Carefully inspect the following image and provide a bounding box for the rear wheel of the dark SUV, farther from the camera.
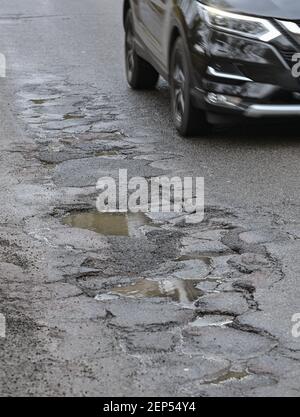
[125,10,159,90]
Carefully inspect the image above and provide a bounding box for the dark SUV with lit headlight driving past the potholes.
[124,0,300,135]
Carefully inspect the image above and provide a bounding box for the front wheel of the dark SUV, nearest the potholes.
[170,37,209,136]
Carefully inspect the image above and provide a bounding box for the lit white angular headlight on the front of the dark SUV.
[199,4,281,42]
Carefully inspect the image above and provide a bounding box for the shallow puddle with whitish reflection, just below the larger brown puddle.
[106,279,203,304]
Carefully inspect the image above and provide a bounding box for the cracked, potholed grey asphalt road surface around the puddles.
[0,0,300,397]
